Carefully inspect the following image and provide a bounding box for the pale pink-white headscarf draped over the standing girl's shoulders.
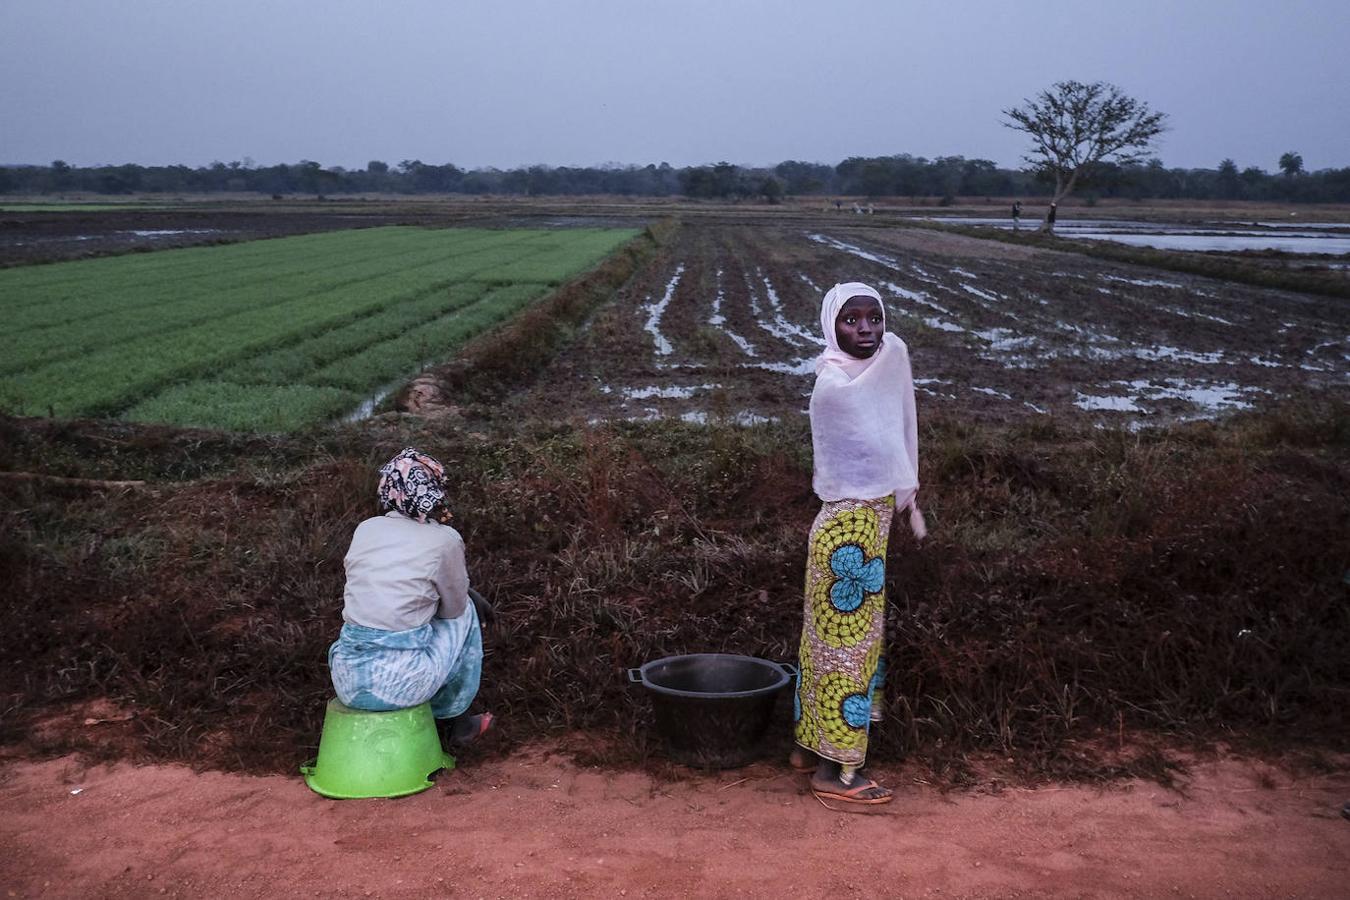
[810,282,925,537]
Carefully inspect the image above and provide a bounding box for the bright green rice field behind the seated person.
[0,227,637,430]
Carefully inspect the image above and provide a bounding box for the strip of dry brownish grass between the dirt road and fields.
[0,405,1350,781]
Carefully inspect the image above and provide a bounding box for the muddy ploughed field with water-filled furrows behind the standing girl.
[507,223,1350,428]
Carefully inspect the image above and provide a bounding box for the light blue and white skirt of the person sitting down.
[328,603,483,719]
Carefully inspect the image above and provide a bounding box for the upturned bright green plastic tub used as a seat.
[300,699,455,800]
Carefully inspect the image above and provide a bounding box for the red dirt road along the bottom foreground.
[0,752,1350,897]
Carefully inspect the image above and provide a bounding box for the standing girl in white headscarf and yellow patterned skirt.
[791,282,925,804]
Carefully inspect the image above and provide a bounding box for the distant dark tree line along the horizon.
[0,152,1350,202]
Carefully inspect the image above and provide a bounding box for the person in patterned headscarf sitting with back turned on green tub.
[328,448,493,743]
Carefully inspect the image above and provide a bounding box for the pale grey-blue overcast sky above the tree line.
[0,0,1350,170]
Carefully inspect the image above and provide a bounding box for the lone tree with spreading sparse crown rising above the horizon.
[1003,81,1166,231]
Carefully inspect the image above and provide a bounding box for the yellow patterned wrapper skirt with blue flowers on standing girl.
[792,497,895,766]
